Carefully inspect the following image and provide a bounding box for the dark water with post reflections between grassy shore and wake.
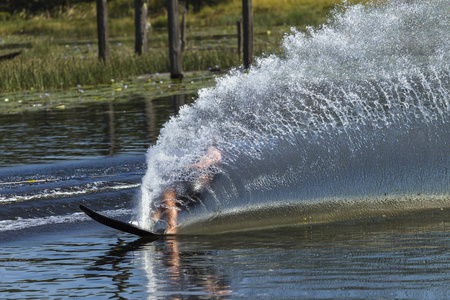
[0,95,193,167]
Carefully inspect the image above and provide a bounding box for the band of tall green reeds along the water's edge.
[0,49,244,92]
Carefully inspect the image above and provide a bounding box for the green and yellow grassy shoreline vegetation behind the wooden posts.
[0,0,362,113]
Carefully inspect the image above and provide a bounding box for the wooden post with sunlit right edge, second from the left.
[134,0,148,55]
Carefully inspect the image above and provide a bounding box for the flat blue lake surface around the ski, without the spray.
[0,98,450,299]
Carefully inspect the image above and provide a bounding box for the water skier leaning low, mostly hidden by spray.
[153,146,222,234]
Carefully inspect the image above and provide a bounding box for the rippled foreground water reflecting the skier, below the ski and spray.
[0,211,450,299]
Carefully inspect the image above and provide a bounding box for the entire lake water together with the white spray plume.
[0,0,450,299]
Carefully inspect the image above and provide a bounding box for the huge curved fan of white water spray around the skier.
[138,0,450,233]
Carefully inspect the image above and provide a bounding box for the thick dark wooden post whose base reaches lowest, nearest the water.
[167,0,183,79]
